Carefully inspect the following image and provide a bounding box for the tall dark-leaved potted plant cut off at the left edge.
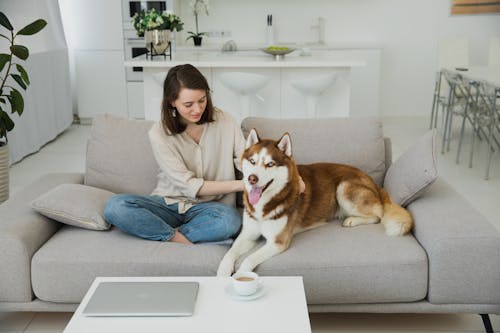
[0,12,47,203]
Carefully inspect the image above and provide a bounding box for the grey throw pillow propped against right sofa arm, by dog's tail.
[384,130,437,207]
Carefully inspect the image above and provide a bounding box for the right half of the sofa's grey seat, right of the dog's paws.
[252,221,428,304]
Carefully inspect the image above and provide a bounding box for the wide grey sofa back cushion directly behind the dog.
[242,117,386,185]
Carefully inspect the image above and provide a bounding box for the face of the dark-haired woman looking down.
[172,88,207,125]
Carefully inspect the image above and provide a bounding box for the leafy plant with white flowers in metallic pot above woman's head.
[132,8,184,55]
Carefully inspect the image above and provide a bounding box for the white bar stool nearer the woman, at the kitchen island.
[219,72,271,119]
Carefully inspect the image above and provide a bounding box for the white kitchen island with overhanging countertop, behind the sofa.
[125,50,372,120]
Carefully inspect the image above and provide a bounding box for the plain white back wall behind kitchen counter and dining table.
[178,0,500,116]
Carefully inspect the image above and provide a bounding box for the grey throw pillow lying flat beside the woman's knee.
[31,184,114,230]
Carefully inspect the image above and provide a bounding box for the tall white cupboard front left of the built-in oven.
[57,0,127,121]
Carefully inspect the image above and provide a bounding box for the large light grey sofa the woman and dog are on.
[0,115,500,330]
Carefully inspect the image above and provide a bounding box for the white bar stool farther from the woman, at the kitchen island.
[291,72,338,118]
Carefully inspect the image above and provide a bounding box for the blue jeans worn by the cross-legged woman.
[104,194,242,243]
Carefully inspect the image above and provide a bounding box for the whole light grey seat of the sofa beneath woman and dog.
[32,221,428,304]
